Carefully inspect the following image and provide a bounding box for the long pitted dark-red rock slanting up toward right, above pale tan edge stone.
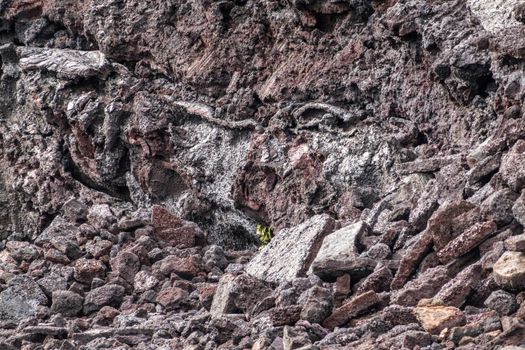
[437,221,497,264]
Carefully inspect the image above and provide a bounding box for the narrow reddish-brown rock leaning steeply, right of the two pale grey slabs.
[390,230,433,289]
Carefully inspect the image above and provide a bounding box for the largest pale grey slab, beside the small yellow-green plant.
[246,214,334,282]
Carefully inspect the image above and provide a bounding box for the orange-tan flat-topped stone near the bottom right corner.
[414,306,466,335]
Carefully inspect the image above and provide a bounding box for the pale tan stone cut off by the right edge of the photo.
[493,252,525,290]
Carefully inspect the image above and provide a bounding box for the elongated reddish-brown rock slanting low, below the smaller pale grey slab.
[323,291,380,328]
